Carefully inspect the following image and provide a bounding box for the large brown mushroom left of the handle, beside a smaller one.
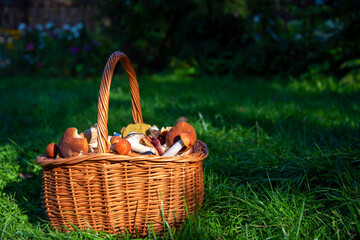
[58,127,89,158]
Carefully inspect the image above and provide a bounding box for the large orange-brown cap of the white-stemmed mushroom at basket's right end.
[166,122,196,152]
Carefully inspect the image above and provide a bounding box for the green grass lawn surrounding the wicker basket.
[0,72,360,239]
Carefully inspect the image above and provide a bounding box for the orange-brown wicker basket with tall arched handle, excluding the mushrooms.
[36,52,208,235]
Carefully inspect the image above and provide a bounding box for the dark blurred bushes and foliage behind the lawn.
[0,0,360,81]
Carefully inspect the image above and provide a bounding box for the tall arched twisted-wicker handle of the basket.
[97,52,143,153]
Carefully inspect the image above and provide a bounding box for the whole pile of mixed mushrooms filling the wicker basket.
[46,121,196,158]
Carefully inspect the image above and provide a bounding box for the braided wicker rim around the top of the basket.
[35,140,209,168]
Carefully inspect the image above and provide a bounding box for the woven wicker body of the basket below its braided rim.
[43,160,204,236]
